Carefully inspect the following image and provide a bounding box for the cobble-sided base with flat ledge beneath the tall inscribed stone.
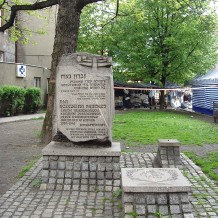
[41,141,121,191]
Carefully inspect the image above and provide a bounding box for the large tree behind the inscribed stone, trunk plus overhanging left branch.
[0,0,100,143]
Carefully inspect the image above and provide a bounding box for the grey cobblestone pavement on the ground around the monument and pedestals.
[0,153,218,218]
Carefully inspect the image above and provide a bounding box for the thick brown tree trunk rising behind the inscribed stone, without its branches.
[41,0,83,143]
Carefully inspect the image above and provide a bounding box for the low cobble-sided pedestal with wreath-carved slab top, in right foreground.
[121,168,193,218]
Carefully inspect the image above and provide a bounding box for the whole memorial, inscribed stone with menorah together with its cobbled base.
[42,53,121,190]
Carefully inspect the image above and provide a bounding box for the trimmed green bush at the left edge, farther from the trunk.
[0,86,25,116]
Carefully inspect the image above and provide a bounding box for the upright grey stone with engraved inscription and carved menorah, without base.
[53,53,114,146]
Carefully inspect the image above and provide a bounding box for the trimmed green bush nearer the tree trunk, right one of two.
[24,88,42,113]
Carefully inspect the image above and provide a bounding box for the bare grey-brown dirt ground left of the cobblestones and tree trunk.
[0,120,44,196]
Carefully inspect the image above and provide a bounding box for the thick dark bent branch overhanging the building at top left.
[0,0,58,31]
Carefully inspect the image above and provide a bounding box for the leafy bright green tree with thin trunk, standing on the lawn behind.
[79,0,217,106]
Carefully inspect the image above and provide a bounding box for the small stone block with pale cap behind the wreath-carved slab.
[154,139,181,168]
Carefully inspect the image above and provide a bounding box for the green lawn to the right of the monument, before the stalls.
[113,111,218,146]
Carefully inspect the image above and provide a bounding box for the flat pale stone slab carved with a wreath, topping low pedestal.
[121,168,191,192]
